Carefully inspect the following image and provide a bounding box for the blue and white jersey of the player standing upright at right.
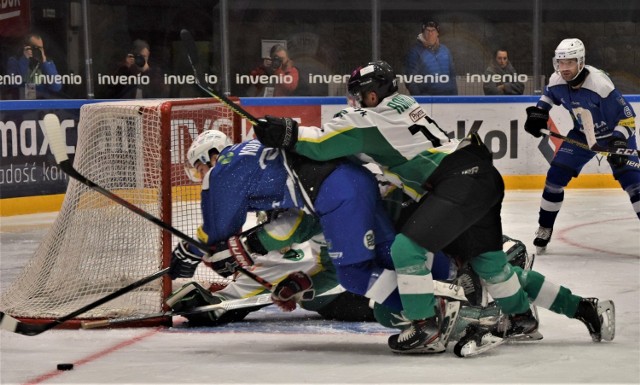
[537,66,635,146]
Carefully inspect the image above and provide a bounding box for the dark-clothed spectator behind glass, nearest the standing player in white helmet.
[483,48,524,95]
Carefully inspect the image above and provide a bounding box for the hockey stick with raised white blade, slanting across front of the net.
[44,114,273,290]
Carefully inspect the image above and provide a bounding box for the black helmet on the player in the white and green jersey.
[347,60,398,106]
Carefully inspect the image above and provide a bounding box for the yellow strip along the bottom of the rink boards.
[0,174,620,217]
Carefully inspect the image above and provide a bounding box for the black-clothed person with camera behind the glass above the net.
[109,39,169,99]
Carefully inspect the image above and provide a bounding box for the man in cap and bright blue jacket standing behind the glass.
[405,20,458,95]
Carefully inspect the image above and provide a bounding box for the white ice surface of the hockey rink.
[0,189,640,384]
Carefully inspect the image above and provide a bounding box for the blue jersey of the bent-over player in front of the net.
[198,140,303,245]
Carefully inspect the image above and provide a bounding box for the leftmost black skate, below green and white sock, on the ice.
[388,298,460,354]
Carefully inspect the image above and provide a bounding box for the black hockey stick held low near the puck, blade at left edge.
[0,267,169,336]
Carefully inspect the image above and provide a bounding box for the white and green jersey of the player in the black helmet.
[295,93,459,200]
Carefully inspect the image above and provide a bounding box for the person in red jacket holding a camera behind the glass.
[251,44,300,96]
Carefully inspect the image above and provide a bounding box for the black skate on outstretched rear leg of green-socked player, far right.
[575,298,616,342]
